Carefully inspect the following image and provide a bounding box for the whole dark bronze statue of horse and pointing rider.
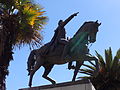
[27,12,101,87]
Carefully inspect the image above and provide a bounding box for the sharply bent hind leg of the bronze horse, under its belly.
[42,64,56,84]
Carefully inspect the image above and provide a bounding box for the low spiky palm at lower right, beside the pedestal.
[80,48,120,90]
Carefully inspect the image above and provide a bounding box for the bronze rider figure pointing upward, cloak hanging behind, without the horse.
[47,12,78,53]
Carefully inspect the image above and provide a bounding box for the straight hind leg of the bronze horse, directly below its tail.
[29,59,43,87]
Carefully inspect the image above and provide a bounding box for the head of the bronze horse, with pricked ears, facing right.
[85,20,101,43]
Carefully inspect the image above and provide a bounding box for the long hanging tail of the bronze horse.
[27,50,36,75]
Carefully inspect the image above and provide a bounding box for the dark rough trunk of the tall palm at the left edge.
[0,16,13,90]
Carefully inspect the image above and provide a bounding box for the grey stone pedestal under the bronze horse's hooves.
[19,80,95,90]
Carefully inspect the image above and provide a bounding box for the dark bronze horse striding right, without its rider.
[28,21,101,87]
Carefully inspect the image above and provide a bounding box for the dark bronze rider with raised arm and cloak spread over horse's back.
[41,12,78,56]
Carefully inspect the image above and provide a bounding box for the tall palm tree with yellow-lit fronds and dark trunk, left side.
[0,0,47,90]
